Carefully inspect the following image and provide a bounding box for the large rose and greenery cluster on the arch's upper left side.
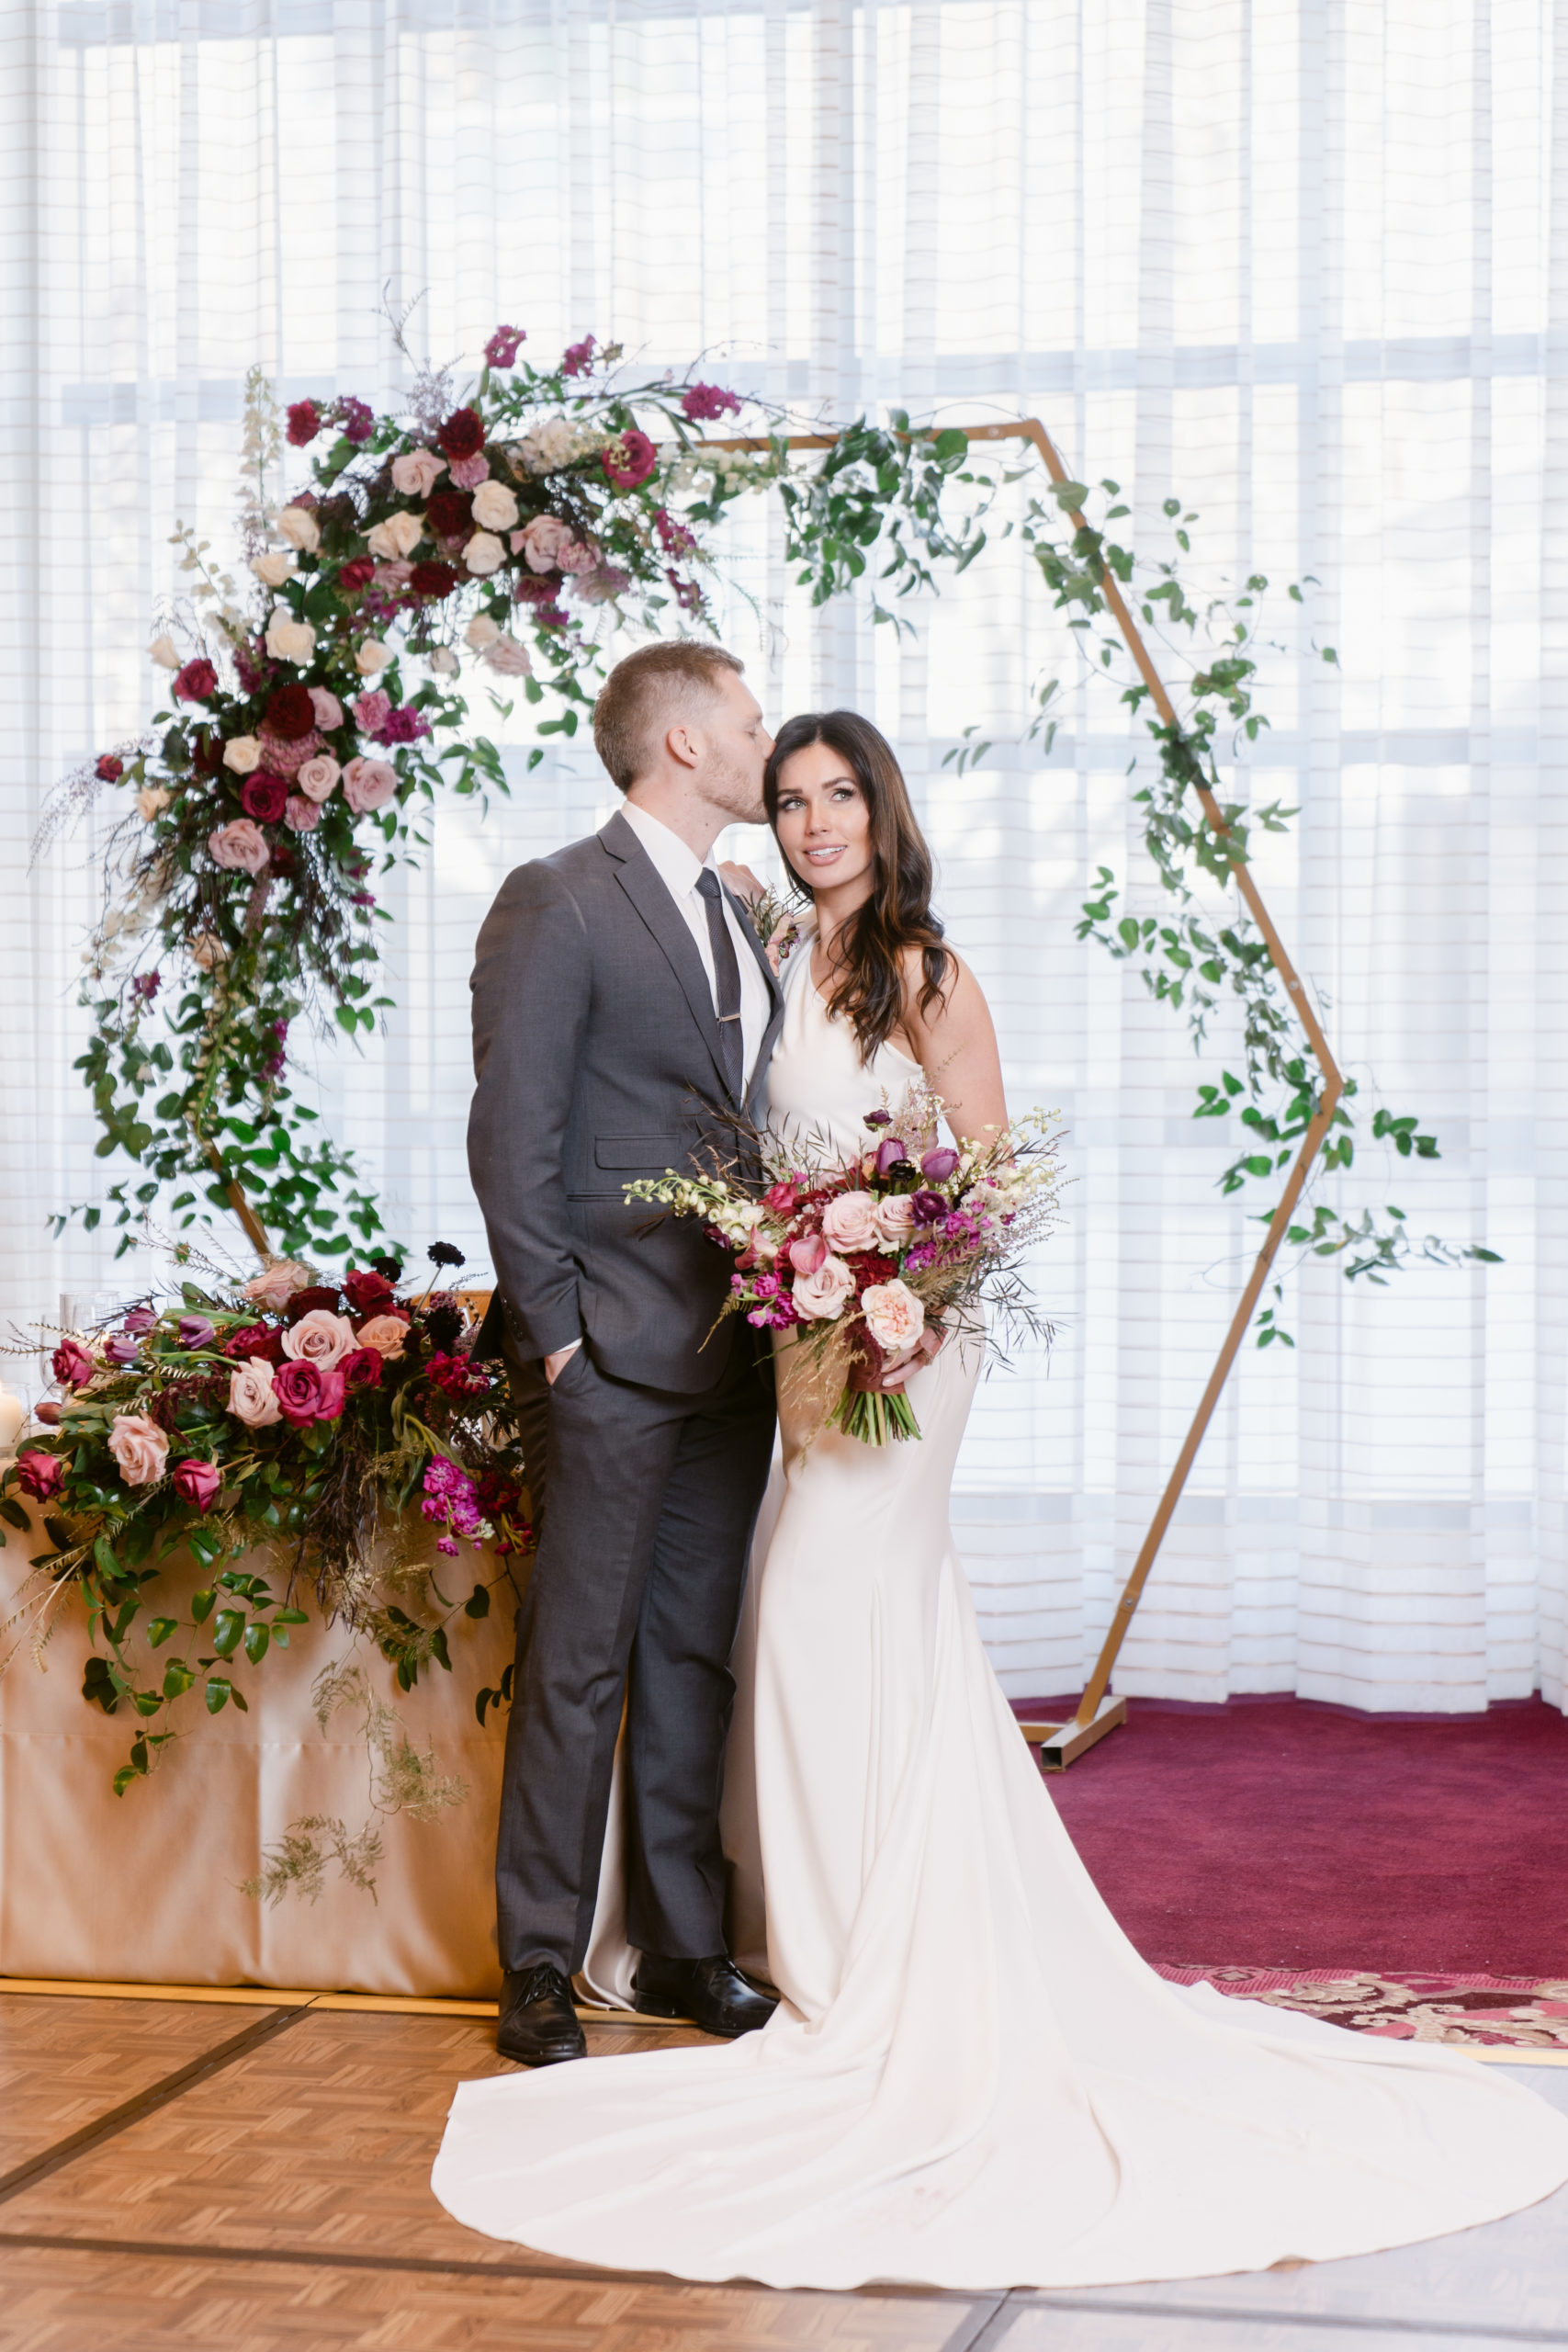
[40,327,983,1259]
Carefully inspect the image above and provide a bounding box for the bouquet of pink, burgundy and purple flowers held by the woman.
[626,1084,1060,1446]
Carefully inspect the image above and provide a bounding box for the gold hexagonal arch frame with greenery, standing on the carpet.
[724,416,1345,1771]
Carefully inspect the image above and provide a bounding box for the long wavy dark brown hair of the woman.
[761,710,952,1061]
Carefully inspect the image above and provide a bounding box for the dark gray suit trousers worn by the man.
[496,1322,773,1973]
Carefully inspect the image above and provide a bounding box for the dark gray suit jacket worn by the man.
[468,814,783,1395]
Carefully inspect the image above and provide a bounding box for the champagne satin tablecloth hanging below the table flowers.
[0,1529,513,1999]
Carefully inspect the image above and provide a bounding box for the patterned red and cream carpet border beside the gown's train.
[1156,1964,1568,2051]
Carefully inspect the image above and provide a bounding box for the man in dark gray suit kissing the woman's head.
[468,644,783,2065]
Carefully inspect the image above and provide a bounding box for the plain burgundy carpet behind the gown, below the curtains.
[1016,1698,1568,1978]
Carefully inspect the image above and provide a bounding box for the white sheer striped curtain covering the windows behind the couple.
[0,0,1568,1710]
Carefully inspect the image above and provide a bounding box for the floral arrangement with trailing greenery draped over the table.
[0,1242,534,1898]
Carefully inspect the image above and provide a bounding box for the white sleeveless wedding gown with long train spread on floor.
[433,945,1568,2289]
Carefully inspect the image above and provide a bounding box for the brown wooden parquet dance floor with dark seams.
[0,1992,1004,2352]
